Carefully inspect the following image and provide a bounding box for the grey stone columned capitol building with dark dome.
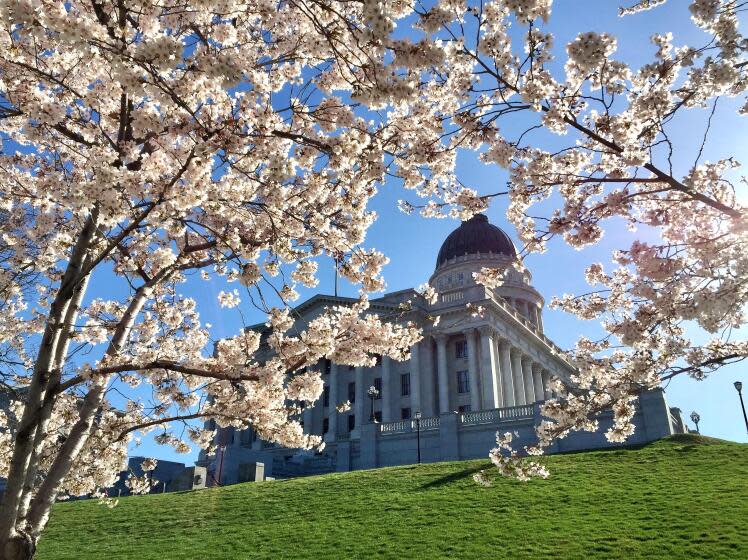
[198,214,685,484]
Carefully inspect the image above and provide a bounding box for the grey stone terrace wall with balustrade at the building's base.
[215,389,684,484]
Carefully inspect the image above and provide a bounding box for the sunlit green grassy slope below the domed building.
[39,436,748,560]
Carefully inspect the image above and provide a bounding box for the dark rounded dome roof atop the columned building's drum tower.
[436,214,517,270]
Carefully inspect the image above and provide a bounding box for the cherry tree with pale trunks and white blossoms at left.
[0,0,426,559]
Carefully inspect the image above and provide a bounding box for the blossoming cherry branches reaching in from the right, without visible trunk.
[398,0,748,479]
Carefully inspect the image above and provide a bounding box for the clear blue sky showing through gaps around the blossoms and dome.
[79,0,748,463]
